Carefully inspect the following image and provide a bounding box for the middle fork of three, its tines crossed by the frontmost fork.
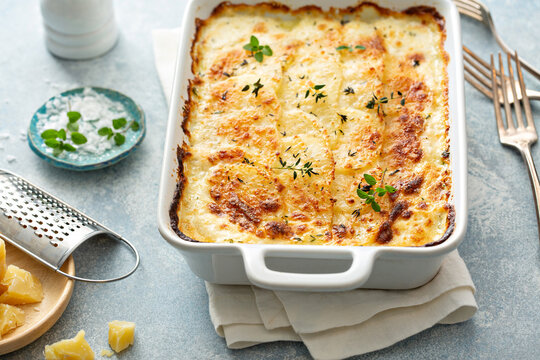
[463,45,540,104]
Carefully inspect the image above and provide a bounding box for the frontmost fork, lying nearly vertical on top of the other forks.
[491,52,540,239]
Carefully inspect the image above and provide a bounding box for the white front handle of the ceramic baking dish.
[241,246,378,291]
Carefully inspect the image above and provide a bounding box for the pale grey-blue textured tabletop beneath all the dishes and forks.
[0,0,540,359]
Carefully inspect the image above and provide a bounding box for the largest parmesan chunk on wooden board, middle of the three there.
[0,265,43,305]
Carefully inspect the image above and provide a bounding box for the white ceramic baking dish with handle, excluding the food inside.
[158,0,467,291]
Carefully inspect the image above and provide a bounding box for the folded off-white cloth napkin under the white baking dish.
[152,29,477,359]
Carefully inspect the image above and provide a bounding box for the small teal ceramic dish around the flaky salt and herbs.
[28,87,146,171]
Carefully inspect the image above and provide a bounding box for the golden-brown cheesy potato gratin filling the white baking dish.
[170,3,454,246]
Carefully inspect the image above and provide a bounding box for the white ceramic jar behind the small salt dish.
[41,0,118,60]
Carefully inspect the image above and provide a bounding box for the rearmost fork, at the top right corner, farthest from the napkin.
[454,0,540,80]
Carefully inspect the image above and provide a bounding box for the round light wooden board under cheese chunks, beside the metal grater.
[0,241,75,355]
